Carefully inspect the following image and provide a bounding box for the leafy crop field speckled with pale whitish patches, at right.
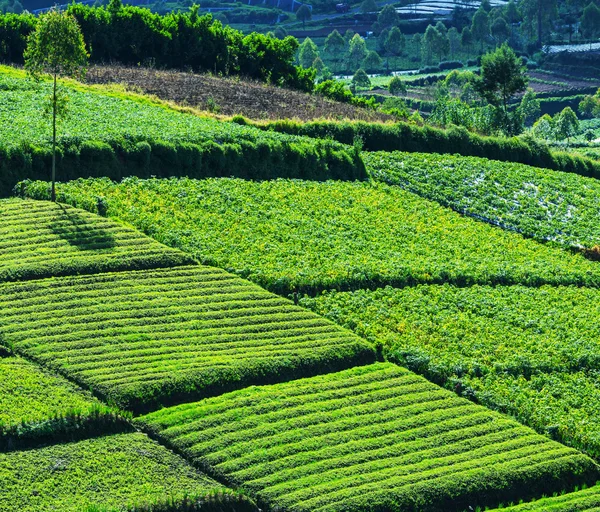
[363,152,600,247]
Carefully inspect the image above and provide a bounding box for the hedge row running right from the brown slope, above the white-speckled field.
[246,120,600,178]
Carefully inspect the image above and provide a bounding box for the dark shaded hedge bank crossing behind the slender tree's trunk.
[0,139,366,197]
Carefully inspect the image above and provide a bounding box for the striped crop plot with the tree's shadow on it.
[0,199,192,281]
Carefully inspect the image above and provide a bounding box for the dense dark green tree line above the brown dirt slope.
[0,0,315,91]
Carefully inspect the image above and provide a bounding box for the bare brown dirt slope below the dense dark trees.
[86,66,392,121]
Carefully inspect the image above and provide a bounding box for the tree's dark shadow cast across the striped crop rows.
[51,204,116,251]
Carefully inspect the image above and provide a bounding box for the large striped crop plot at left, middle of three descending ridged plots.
[0,266,375,411]
